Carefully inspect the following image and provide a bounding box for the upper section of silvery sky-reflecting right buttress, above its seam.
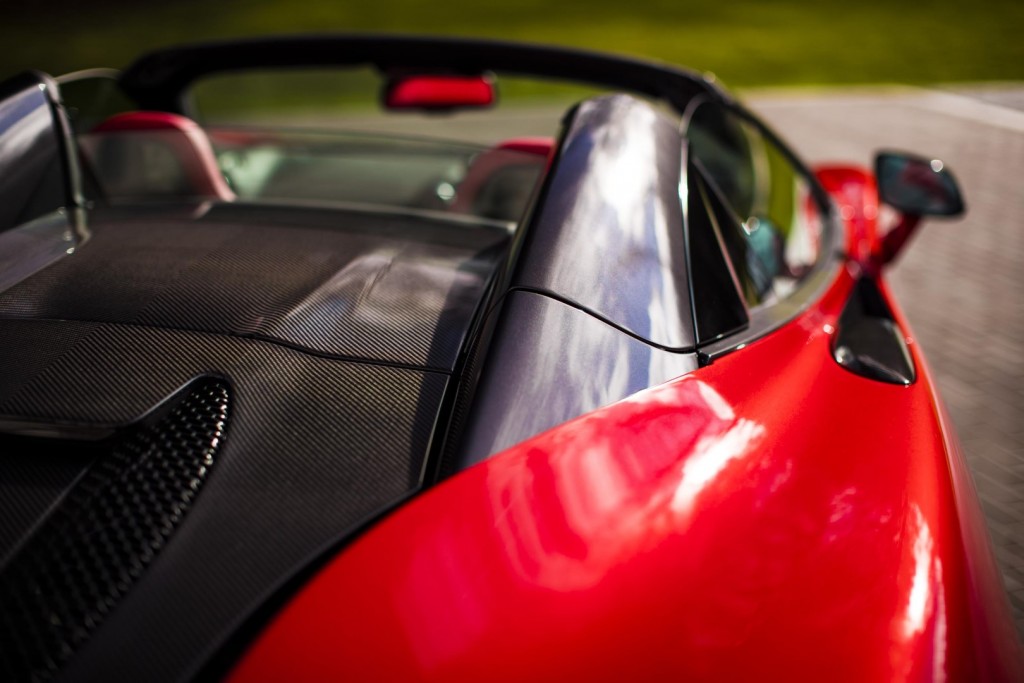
[512,94,694,352]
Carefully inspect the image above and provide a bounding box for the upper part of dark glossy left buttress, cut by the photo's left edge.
[0,75,69,230]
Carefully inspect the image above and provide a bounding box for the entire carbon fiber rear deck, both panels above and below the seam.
[0,209,487,681]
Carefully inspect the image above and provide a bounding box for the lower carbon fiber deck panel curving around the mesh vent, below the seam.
[0,318,446,681]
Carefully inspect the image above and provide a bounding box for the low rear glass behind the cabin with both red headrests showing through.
[79,124,551,223]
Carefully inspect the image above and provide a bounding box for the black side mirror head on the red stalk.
[874,152,964,216]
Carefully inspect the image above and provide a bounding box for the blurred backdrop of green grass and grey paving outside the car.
[6,0,1024,634]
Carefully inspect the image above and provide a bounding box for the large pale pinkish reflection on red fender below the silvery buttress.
[489,380,765,591]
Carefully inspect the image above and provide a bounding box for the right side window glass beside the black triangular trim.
[687,102,824,306]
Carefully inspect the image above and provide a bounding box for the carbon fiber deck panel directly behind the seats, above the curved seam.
[0,205,508,371]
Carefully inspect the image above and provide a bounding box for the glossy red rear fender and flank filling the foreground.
[231,259,1024,683]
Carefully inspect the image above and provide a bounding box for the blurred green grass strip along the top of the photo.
[0,0,1024,87]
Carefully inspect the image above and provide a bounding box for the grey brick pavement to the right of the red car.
[744,84,1024,639]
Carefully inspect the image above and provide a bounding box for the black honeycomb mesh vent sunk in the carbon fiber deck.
[0,378,228,680]
